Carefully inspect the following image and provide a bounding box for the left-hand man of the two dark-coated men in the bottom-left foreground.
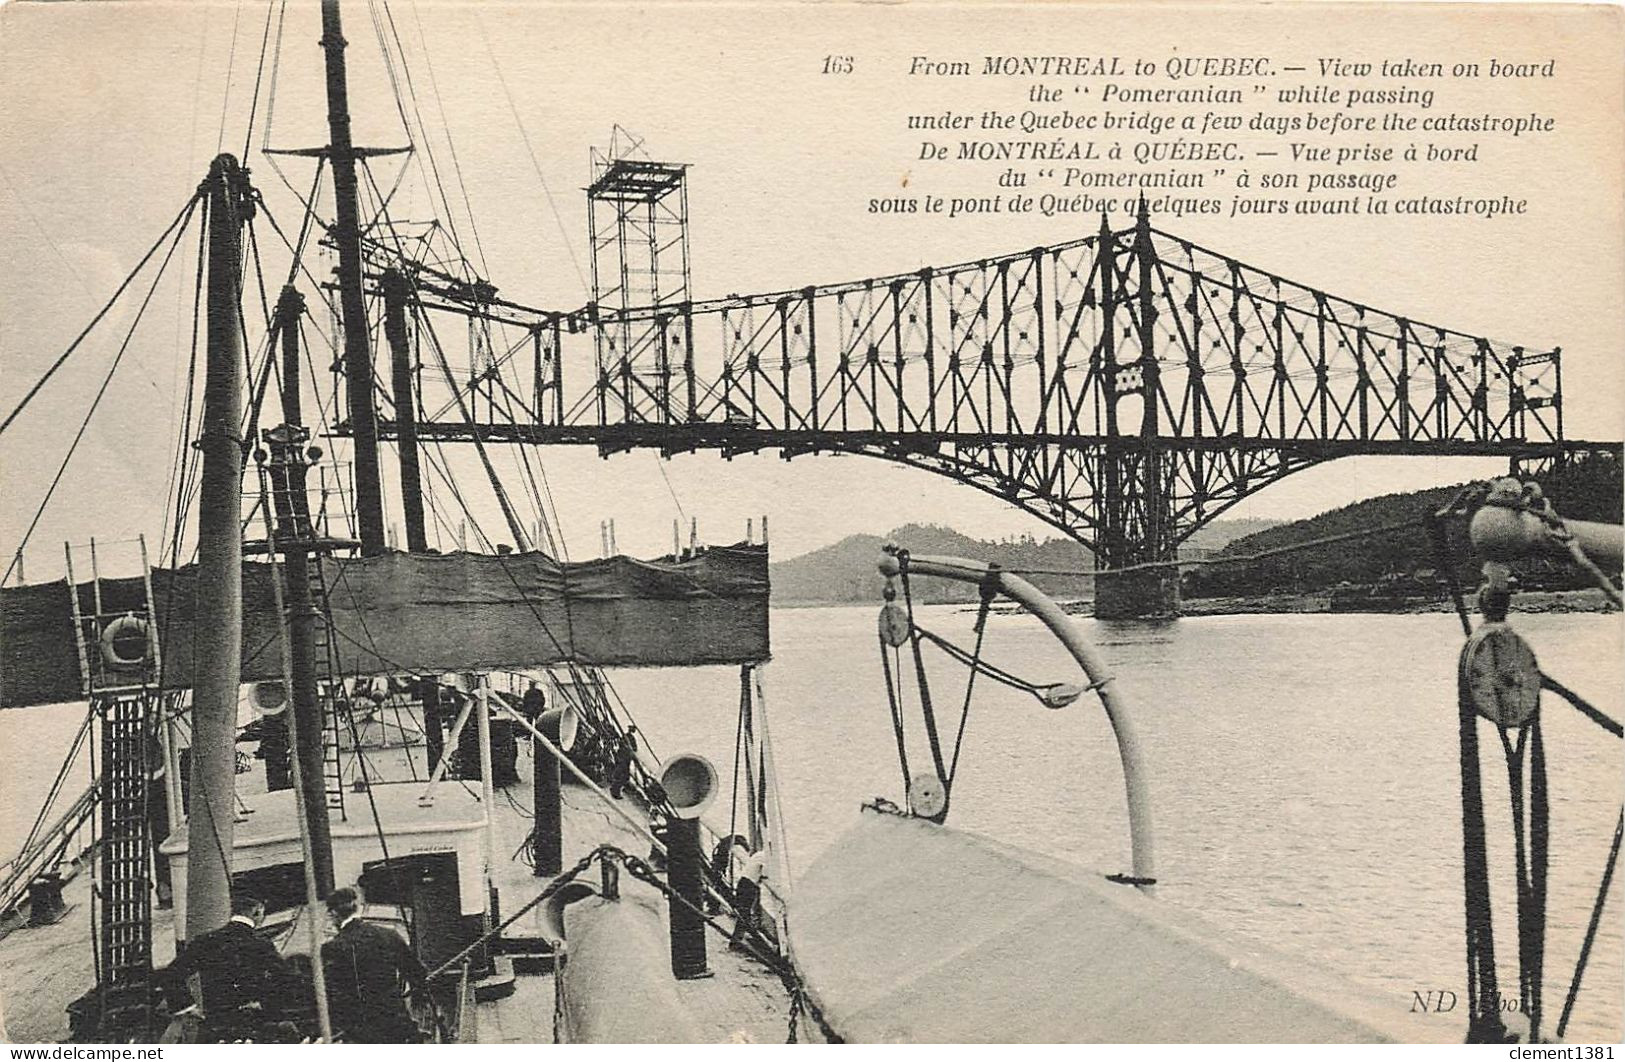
[159,893,283,1043]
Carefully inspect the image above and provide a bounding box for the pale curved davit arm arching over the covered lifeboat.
[881,554,1157,890]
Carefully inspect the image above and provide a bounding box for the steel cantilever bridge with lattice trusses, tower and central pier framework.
[362,177,1619,617]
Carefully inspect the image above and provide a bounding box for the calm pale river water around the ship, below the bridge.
[0,606,1625,1041]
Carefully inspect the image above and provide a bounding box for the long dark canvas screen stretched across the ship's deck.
[0,546,769,708]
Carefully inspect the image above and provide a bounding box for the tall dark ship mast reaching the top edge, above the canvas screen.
[322,0,384,557]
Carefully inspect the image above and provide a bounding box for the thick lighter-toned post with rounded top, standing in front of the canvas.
[185,154,252,940]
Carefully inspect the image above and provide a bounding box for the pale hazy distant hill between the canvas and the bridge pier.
[769,523,1094,604]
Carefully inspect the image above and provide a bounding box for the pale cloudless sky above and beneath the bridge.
[0,0,1625,581]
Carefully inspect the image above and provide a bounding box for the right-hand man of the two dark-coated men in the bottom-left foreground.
[322,888,427,1044]
